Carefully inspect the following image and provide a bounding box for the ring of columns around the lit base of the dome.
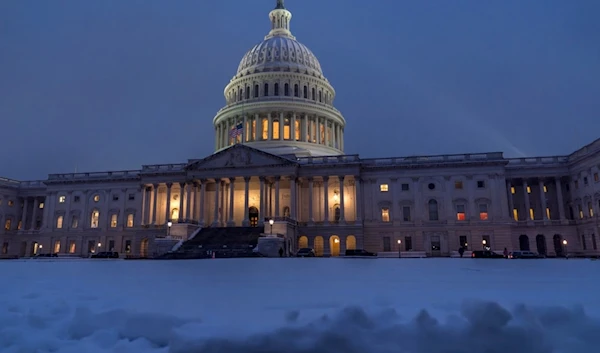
[215,113,344,150]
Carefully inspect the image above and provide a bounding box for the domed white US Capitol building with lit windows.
[0,0,600,257]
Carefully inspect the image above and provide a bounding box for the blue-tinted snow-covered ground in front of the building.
[0,258,600,353]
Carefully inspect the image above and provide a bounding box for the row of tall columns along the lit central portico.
[143,176,361,226]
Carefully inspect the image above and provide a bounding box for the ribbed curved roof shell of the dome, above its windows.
[237,36,323,77]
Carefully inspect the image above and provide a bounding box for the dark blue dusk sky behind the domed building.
[0,0,600,180]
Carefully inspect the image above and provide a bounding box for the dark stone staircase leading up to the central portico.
[159,227,261,260]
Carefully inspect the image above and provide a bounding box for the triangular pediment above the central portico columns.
[187,144,296,170]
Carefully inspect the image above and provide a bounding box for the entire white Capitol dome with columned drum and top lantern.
[213,0,346,156]
